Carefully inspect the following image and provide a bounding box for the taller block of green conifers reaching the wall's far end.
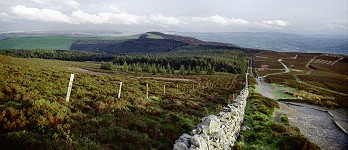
[113,50,247,74]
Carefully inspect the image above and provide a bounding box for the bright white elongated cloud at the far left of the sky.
[11,5,73,23]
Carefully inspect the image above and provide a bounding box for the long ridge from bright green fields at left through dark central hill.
[0,31,260,54]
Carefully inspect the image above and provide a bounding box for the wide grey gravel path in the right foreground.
[276,103,348,150]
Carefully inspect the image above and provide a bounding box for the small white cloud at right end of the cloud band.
[191,15,249,25]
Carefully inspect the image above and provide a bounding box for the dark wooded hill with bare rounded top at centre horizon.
[70,32,241,54]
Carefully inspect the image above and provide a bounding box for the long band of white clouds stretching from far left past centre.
[6,4,249,27]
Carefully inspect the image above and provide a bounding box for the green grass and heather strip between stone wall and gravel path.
[233,79,320,150]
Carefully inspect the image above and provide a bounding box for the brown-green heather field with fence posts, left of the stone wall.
[0,55,244,149]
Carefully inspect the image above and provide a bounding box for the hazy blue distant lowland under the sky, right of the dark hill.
[174,32,348,55]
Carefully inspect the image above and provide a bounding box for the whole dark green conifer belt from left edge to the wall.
[0,49,247,74]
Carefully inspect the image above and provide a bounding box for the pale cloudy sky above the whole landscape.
[0,0,348,34]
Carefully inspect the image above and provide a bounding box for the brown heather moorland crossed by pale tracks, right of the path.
[254,52,348,108]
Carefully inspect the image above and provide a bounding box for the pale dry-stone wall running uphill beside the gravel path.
[174,75,249,150]
